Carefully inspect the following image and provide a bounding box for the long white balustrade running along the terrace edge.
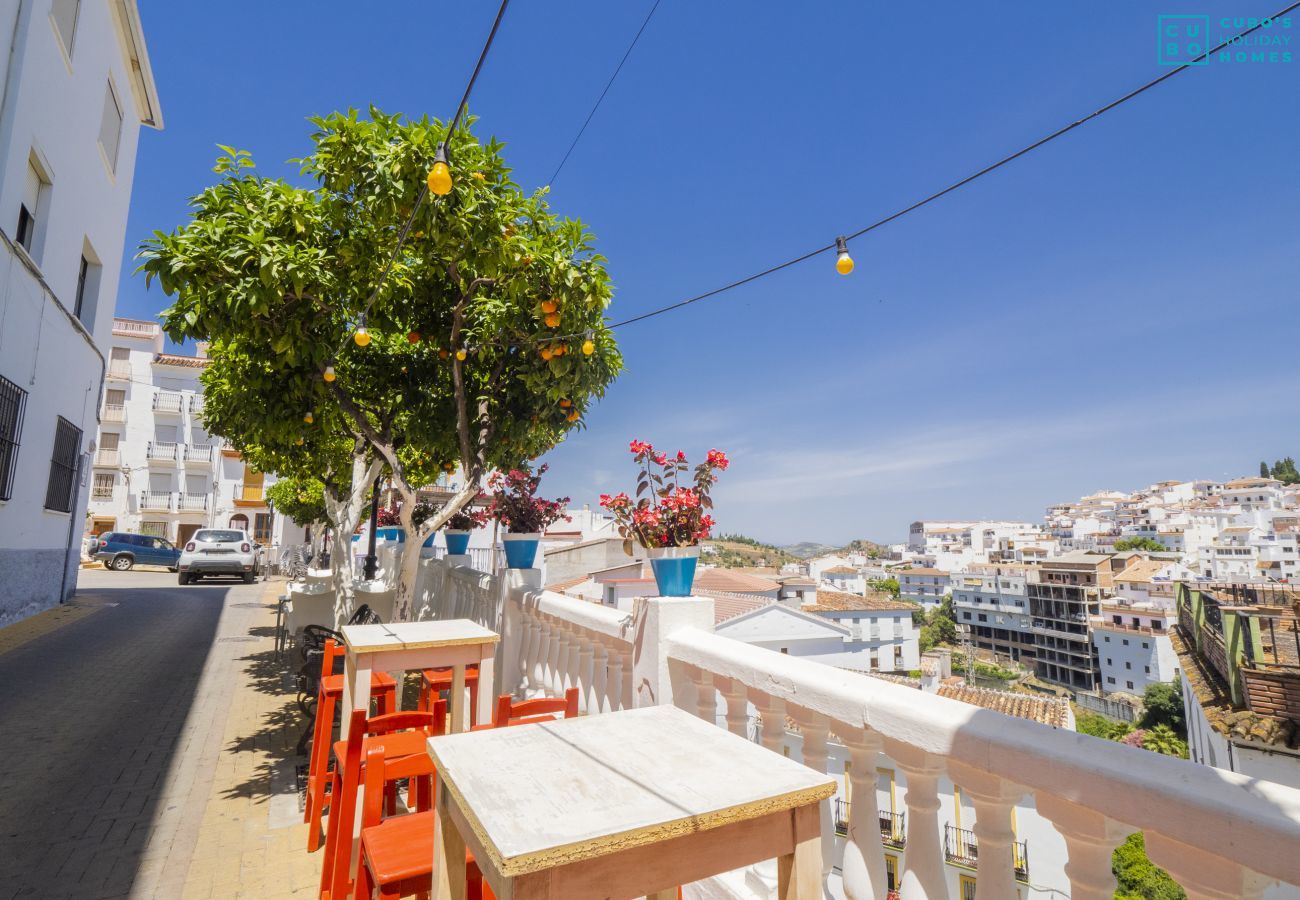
[398,559,1300,900]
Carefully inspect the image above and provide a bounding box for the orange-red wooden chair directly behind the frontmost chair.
[320,700,447,897]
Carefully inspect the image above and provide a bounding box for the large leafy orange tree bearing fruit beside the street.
[142,108,621,611]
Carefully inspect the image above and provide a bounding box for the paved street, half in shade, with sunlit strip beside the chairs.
[0,570,320,899]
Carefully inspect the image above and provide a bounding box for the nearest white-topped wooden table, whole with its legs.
[429,706,835,900]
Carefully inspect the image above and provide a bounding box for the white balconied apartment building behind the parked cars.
[90,319,287,545]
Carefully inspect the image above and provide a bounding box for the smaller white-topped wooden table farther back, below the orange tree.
[339,619,501,740]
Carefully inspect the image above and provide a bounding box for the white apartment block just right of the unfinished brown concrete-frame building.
[1091,603,1179,697]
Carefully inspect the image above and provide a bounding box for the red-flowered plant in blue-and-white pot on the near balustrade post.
[601,441,731,597]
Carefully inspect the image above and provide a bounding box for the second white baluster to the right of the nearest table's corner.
[884,739,946,900]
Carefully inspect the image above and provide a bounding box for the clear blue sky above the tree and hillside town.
[118,0,1300,542]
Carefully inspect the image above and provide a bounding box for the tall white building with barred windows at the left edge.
[0,0,163,624]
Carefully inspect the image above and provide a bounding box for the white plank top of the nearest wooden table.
[429,706,835,877]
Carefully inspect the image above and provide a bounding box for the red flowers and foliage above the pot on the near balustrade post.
[601,441,731,548]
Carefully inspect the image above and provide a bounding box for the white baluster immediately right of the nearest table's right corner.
[836,724,889,900]
